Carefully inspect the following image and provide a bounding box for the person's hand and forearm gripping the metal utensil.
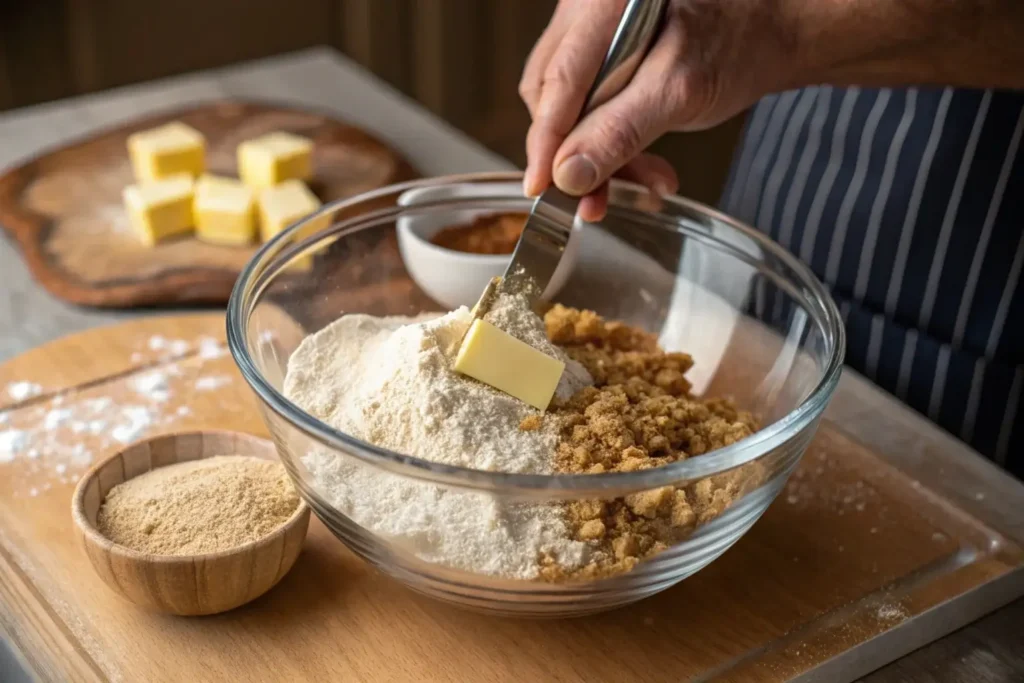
[519,0,1024,220]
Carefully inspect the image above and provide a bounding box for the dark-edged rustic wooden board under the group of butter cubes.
[0,101,416,307]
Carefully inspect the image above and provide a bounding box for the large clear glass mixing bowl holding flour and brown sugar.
[227,173,845,615]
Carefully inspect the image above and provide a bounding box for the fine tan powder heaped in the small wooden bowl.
[97,456,299,555]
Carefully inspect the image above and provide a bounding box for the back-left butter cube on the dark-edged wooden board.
[128,121,206,182]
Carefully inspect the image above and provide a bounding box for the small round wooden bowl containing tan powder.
[72,431,309,615]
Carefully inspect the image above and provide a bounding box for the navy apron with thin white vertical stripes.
[722,87,1024,476]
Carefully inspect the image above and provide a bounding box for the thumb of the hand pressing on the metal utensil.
[552,81,674,197]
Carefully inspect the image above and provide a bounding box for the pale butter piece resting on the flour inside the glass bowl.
[455,319,565,411]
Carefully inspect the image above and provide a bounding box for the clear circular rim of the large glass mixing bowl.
[227,172,846,498]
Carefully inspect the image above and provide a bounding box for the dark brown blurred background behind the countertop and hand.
[0,0,741,203]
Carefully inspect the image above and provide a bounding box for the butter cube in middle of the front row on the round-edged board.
[193,175,256,245]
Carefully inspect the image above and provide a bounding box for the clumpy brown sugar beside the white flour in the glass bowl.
[540,305,764,581]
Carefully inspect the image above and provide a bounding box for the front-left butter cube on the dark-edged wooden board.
[124,173,193,246]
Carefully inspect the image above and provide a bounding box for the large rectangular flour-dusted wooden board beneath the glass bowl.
[0,314,1024,683]
